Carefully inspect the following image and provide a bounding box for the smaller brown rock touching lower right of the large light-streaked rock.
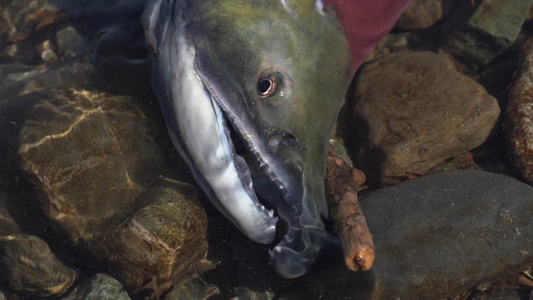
[88,181,209,296]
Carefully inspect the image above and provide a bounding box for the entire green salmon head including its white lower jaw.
[144,0,352,278]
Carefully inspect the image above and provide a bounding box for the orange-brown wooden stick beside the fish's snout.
[326,147,375,271]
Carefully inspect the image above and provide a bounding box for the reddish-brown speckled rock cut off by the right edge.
[504,39,533,184]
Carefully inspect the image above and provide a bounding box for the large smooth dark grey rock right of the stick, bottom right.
[300,170,533,300]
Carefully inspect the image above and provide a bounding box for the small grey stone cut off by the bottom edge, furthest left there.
[61,274,130,300]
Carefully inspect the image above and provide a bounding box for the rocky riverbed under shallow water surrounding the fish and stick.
[0,0,533,299]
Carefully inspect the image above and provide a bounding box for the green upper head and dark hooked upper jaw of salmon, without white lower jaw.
[195,1,352,277]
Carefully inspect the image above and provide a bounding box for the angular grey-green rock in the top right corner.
[441,0,533,68]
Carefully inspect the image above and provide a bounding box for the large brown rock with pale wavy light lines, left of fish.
[19,90,152,240]
